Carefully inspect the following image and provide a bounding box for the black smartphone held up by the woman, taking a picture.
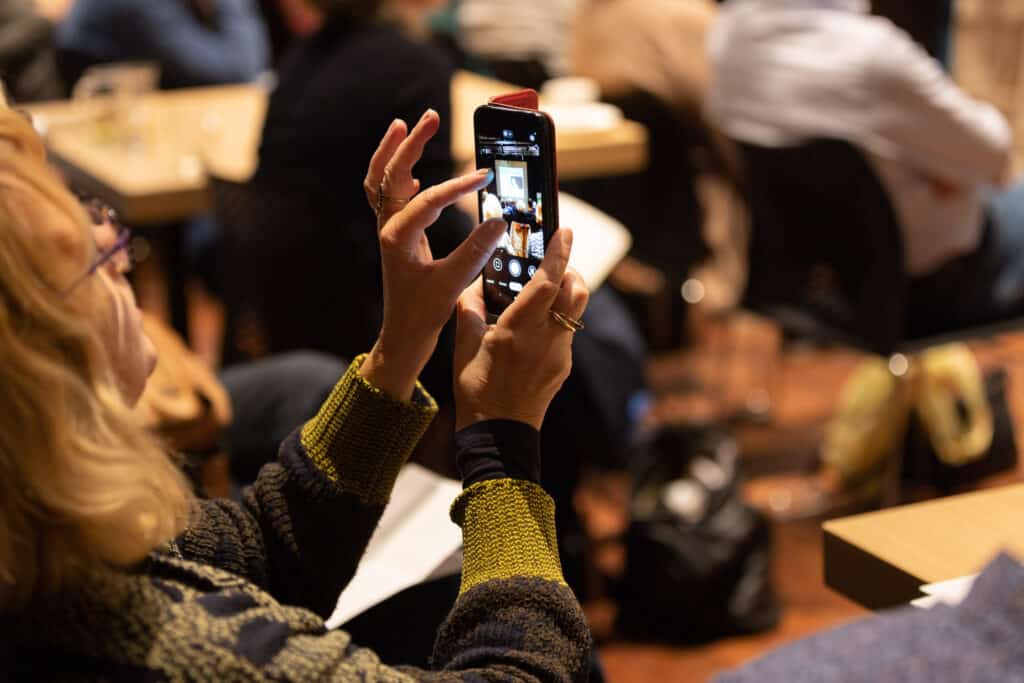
[473,103,558,323]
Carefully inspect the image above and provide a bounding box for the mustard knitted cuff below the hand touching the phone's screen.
[301,354,437,505]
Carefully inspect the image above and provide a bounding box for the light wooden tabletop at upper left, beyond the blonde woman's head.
[28,85,266,225]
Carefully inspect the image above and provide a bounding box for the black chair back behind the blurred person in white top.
[739,139,909,354]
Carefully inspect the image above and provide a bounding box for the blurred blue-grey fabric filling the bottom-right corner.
[718,555,1024,683]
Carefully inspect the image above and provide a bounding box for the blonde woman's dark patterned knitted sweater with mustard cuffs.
[0,358,591,681]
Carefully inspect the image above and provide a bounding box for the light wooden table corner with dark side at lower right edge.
[823,484,1024,609]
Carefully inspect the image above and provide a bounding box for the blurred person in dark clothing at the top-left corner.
[0,0,72,102]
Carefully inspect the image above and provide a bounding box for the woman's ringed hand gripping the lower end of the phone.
[455,228,590,429]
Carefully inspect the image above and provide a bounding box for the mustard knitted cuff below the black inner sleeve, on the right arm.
[452,479,565,594]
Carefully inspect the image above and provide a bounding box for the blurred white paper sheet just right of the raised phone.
[558,193,633,291]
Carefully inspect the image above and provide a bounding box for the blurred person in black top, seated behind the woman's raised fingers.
[256,0,460,232]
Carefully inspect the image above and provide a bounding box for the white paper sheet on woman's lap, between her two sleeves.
[327,464,462,629]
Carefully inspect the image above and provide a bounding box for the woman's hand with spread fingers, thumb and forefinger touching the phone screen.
[360,111,506,400]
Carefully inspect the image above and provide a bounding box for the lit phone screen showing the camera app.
[478,125,545,309]
